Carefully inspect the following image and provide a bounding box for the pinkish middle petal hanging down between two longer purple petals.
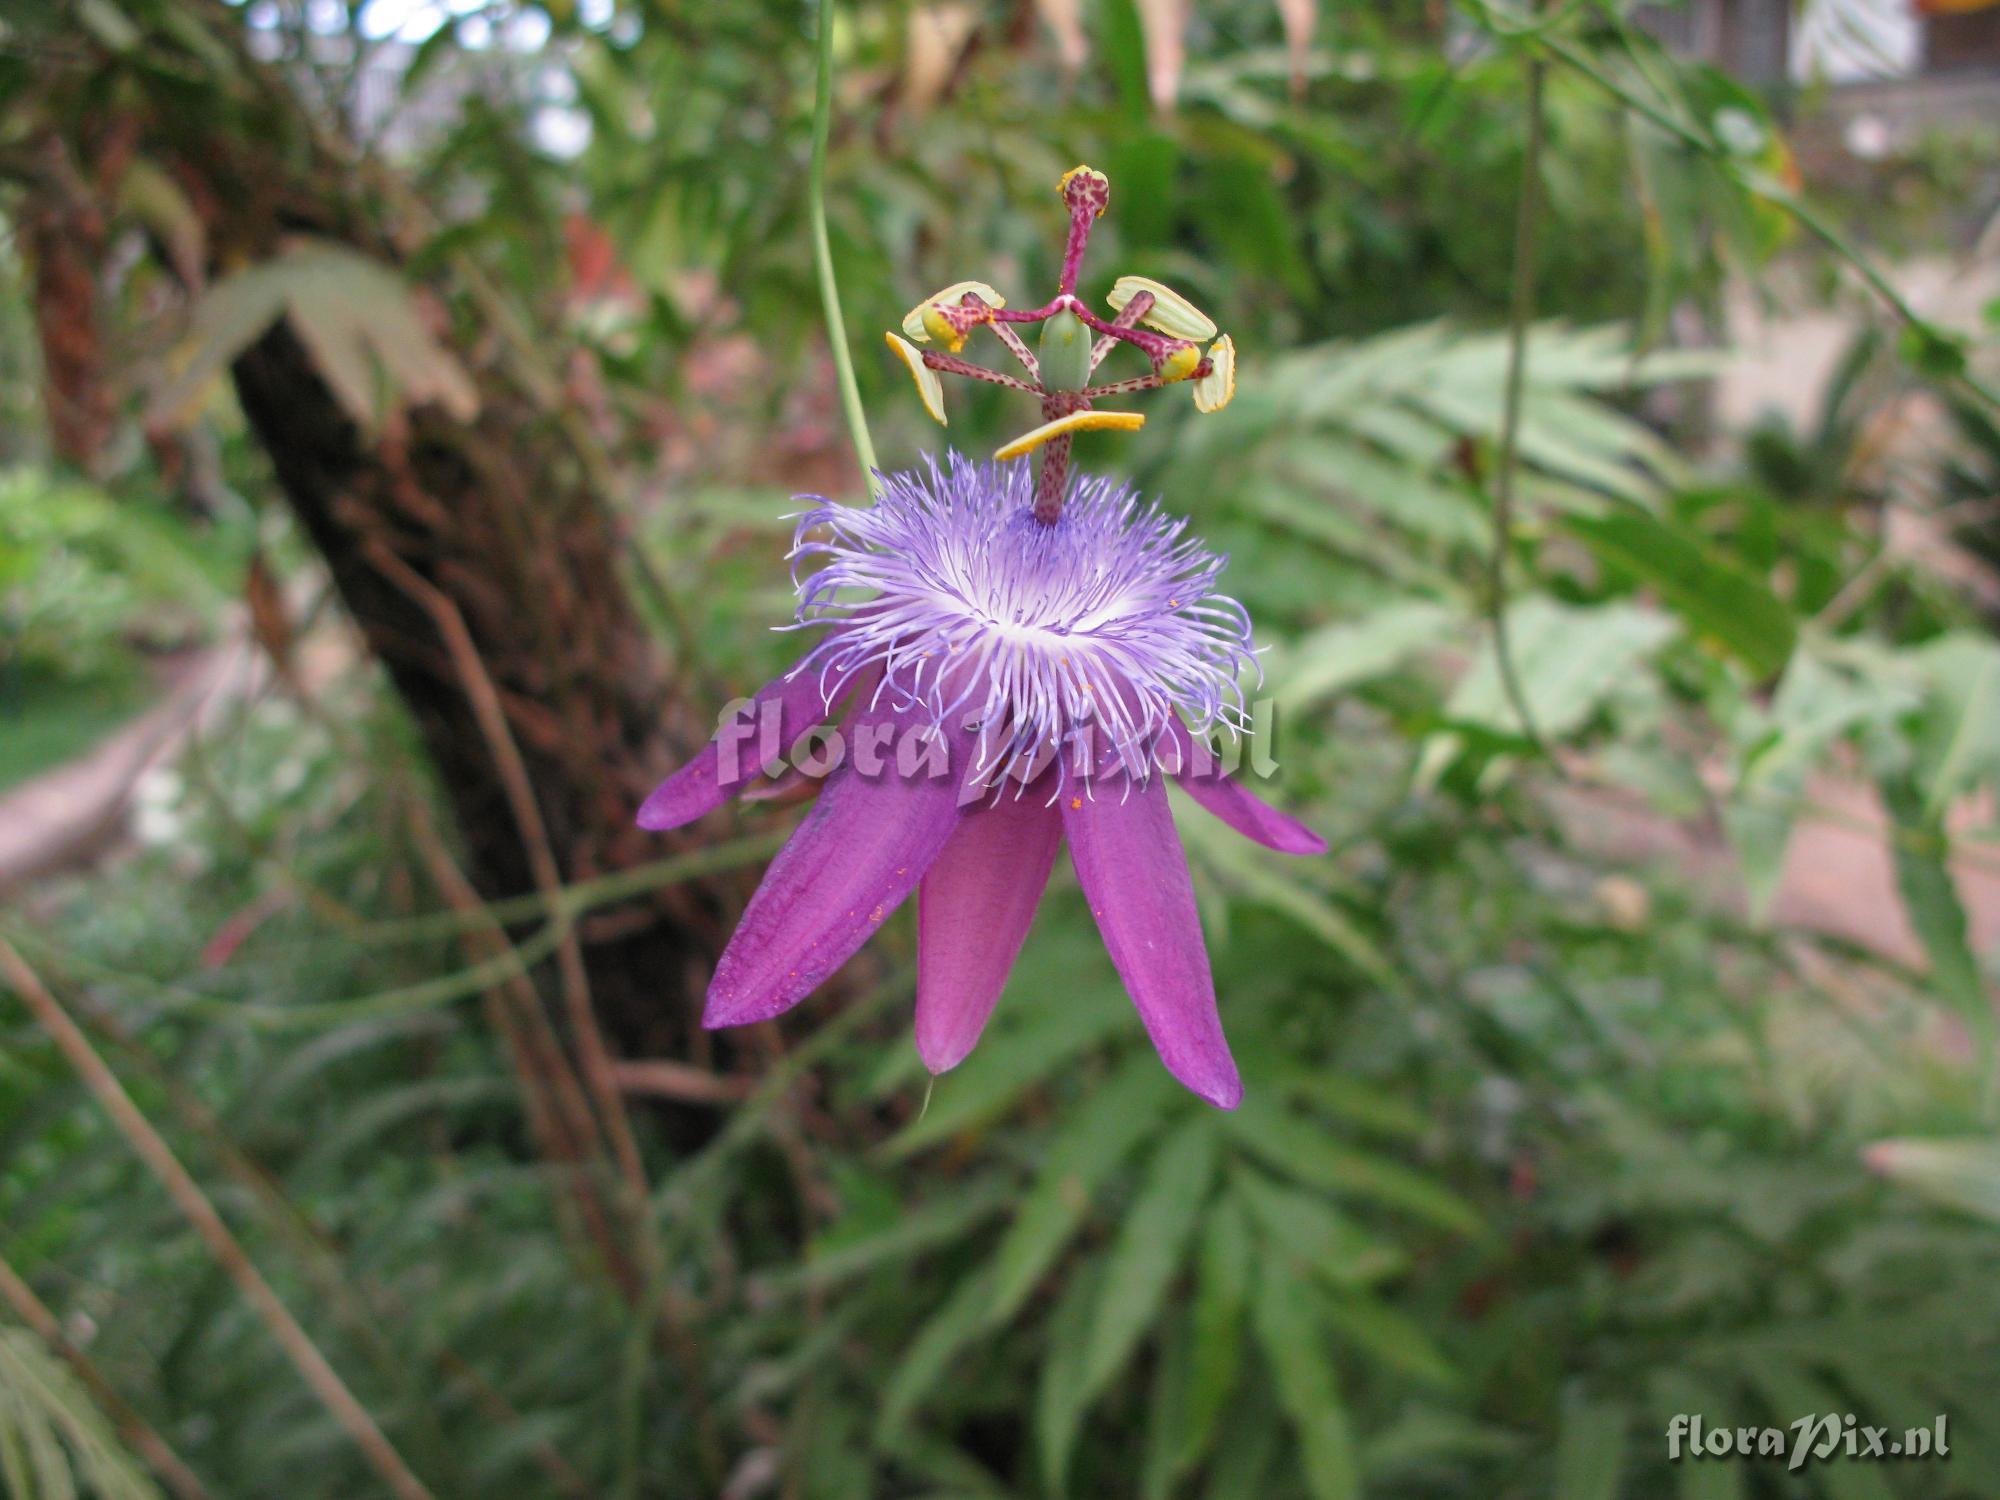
[916,784,1062,1072]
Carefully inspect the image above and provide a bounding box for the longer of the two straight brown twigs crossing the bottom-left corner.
[0,938,434,1500]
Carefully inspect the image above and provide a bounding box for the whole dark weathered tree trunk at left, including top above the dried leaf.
[17,0,720,1052]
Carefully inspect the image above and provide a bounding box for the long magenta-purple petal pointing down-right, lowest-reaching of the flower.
[1062,776,1244,1110]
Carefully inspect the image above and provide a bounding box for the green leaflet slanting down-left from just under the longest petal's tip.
[1084,1114,1216,1396]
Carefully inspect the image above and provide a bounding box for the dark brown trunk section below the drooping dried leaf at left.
[234,322,714,1052]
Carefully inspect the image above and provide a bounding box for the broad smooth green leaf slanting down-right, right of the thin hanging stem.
[1564,508,1798,678]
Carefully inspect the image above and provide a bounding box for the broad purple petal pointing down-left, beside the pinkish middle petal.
[702,704,970,1028]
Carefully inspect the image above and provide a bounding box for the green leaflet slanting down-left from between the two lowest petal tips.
[988,1052,1178,1324]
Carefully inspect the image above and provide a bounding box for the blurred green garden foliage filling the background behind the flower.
[0,0,2000,1500]
